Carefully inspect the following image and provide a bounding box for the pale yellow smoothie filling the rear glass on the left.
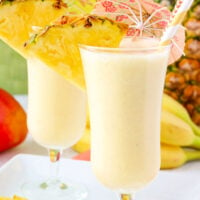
[28,59,87,149]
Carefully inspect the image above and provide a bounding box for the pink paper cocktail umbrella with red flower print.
[92,0,185,64]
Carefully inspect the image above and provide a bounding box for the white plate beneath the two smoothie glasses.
[0,154,200,200]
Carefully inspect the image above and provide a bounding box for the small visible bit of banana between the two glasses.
[72,127,90,153]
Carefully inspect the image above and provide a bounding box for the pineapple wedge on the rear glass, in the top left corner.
[0,0,67,57]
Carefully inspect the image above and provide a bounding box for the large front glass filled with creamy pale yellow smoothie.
[80,38,170,200]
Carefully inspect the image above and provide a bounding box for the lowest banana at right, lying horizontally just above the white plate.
[161,144,200,169]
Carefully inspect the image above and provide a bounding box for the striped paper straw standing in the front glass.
[160,0,193,46]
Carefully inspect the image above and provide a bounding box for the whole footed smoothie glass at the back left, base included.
[22,59,87,200]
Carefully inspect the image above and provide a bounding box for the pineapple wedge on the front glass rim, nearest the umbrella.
[25,15,128,88]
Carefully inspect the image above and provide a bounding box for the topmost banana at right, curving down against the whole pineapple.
[162,94,200,136]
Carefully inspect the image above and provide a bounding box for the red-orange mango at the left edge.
[0,88,27,152]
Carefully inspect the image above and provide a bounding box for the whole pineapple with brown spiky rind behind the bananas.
[156,0,200,125]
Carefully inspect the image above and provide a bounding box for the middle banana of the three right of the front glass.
[161,110,200,149]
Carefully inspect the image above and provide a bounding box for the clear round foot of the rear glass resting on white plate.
[21,180,88,200]
